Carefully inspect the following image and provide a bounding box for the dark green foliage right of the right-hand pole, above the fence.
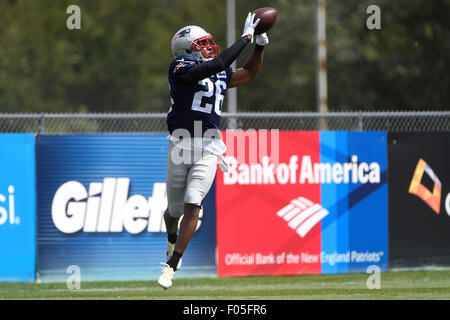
[328,0,450,110]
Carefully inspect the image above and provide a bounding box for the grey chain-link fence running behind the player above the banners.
[0,108,450,134]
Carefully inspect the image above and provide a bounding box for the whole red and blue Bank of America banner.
[216,130,388,276]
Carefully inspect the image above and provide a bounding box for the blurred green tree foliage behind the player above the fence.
[0,0,450,112]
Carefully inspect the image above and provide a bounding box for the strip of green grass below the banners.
[0,270,450,300]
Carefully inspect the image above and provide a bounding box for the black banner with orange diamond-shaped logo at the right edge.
[388,132,450,268]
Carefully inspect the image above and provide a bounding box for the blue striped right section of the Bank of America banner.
[320,131,389,273]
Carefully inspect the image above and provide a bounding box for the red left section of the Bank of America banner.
[216,131,321,276]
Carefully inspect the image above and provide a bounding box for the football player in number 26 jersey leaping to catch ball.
[157,13,269,289]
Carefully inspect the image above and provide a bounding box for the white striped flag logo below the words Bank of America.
[277,197,329,238]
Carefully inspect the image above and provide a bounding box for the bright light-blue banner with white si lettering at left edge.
[0,134,36,281]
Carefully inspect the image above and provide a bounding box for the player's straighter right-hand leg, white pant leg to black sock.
[167,153,217,272]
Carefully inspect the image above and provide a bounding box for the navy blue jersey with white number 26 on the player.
[167,54,232,137]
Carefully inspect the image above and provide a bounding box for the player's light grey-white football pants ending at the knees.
[166,141,217,218]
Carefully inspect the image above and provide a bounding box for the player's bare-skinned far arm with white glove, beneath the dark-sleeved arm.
[228,33,269,88]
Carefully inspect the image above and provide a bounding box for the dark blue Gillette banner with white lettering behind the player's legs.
[36,134,216,281]
